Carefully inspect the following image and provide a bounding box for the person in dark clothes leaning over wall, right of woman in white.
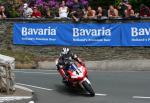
[71,0,84,22]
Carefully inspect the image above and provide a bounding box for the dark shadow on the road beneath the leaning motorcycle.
[55,84,90,97]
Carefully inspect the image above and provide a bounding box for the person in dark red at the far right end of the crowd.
[140,4,150,17]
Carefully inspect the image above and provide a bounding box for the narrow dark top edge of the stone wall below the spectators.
[0,17,150,23]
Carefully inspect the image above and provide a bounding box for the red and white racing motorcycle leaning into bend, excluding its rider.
[55,58,95,96]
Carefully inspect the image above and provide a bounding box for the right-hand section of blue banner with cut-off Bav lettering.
[121,23,150,46]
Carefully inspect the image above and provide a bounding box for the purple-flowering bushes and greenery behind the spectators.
[0,0,150,18]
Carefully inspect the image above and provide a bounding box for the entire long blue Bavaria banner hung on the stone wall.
[13,23,150,46]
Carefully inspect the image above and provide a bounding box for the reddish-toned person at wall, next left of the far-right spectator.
[125,4,135,18]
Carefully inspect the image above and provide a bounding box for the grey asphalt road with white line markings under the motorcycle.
[15,70,150,103]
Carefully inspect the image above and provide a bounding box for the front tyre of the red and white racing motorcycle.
[82,81,95,97]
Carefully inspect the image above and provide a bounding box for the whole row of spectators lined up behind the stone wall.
[0,0,150,21]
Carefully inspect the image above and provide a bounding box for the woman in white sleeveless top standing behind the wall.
[59,1,68,18]
